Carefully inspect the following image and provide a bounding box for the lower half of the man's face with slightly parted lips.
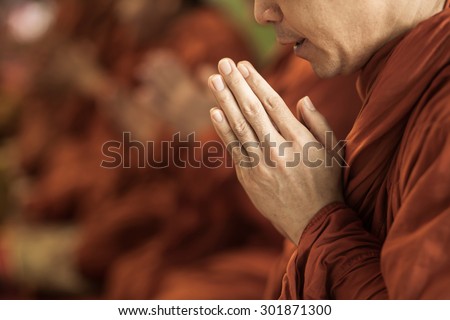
[254,0,388,77]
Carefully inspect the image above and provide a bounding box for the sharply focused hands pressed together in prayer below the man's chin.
[209,59,343,244]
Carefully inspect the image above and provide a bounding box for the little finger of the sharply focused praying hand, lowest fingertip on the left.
[210,108,247,165]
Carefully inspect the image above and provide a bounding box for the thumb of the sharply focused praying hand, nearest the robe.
[297,97,344,164]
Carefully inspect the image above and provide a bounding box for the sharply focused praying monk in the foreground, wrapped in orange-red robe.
[210,0,450,299]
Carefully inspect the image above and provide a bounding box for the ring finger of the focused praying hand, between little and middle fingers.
[209,74,259,150]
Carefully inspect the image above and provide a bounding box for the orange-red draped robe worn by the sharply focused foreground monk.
[281,4,450,299]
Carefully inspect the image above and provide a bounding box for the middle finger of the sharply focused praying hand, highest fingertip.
[219,58,281,141]
